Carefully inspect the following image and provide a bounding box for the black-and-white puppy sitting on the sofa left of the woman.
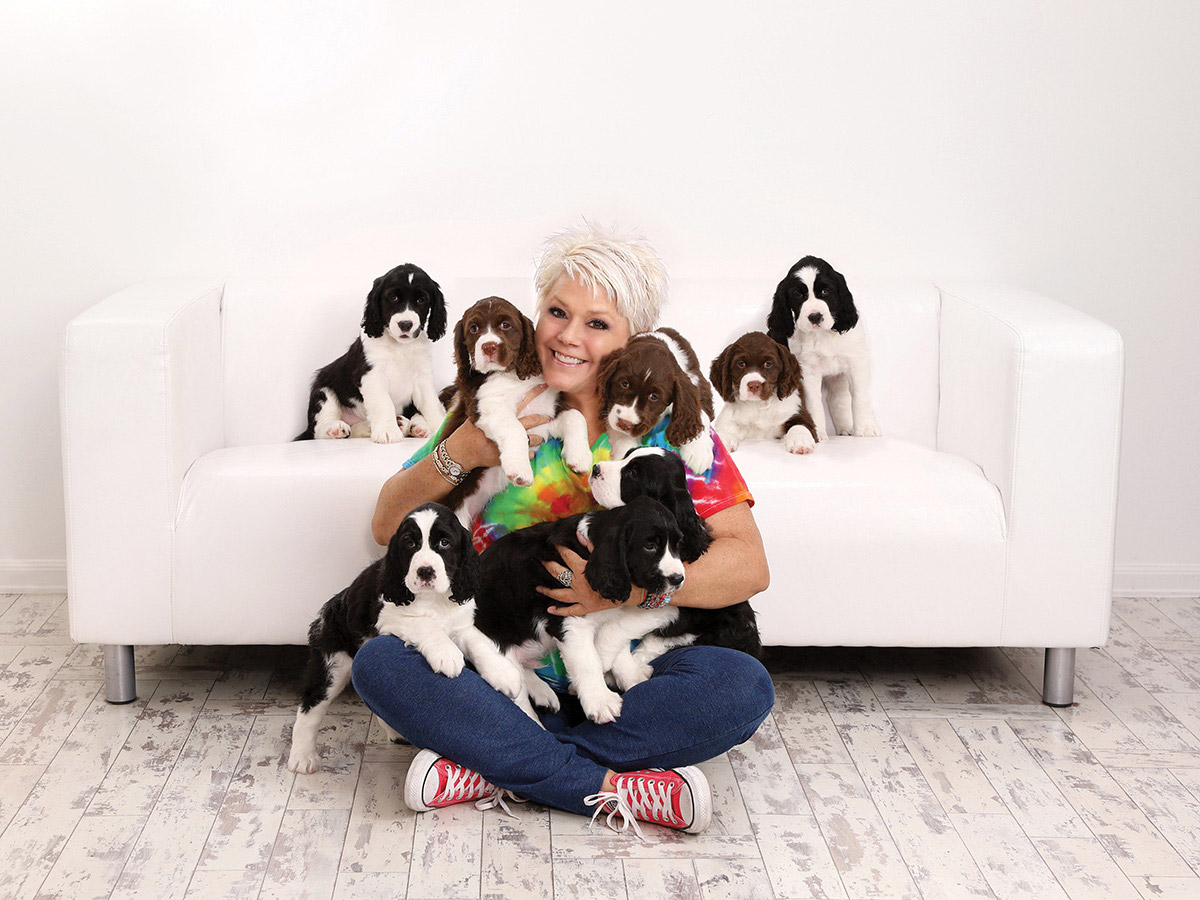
[295,263,446,444]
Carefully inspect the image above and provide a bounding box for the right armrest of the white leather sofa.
[937,284,1124,647]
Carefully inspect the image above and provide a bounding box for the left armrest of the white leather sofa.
[60,281,223,644]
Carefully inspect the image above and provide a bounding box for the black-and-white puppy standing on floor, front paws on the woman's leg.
[288,503,525,774]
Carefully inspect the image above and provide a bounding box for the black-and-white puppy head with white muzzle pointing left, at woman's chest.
[589,446,713,563]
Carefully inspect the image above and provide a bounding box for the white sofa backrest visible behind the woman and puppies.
[222,274,938,448]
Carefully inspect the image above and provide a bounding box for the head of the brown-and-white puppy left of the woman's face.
[454,296,541,384]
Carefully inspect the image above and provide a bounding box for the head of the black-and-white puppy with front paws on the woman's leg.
[380,503,479,606]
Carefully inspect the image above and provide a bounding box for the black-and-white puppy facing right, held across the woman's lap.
[475,496,684,722]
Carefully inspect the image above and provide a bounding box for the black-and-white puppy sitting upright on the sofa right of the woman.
[767,257,881,440]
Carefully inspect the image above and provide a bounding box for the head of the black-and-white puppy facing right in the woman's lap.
[583,496,684,604]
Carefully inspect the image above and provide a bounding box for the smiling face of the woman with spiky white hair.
[535,275,631,397]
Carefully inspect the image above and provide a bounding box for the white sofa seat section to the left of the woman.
[172,438,424,643]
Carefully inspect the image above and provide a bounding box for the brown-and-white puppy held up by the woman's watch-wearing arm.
[443,296,592,520]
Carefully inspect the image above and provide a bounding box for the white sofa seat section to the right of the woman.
[733,437,1006,647]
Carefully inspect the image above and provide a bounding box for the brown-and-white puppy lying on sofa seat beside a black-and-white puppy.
[708,331,817,454]
